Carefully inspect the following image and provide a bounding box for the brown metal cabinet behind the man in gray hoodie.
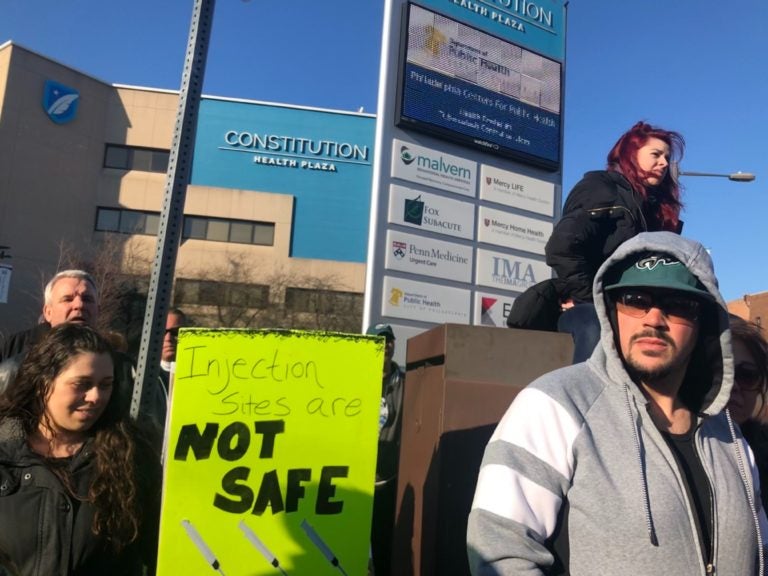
[392,324,573,576]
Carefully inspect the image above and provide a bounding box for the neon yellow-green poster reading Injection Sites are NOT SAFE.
[157,329,384,576]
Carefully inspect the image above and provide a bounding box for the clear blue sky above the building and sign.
[0,0,768,300]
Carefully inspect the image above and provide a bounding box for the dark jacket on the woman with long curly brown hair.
[0,419,160,576]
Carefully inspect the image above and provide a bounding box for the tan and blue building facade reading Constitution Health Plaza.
[0,42,375,346]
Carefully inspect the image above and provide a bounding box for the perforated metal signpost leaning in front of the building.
[131,0,216,419]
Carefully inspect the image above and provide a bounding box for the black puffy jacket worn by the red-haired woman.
[546,170,682,302]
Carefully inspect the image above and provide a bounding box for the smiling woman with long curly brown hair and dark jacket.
[0,323,161,576]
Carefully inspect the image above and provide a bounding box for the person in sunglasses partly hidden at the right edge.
[728,315,768,509]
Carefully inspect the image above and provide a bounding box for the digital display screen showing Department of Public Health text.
[397,4,562,170]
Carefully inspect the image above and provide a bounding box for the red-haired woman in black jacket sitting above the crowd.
[546,122,685,363]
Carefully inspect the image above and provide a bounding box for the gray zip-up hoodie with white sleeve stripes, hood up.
[467,232,768,576]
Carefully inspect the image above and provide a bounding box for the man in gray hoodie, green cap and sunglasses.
[467,232,768,576]
